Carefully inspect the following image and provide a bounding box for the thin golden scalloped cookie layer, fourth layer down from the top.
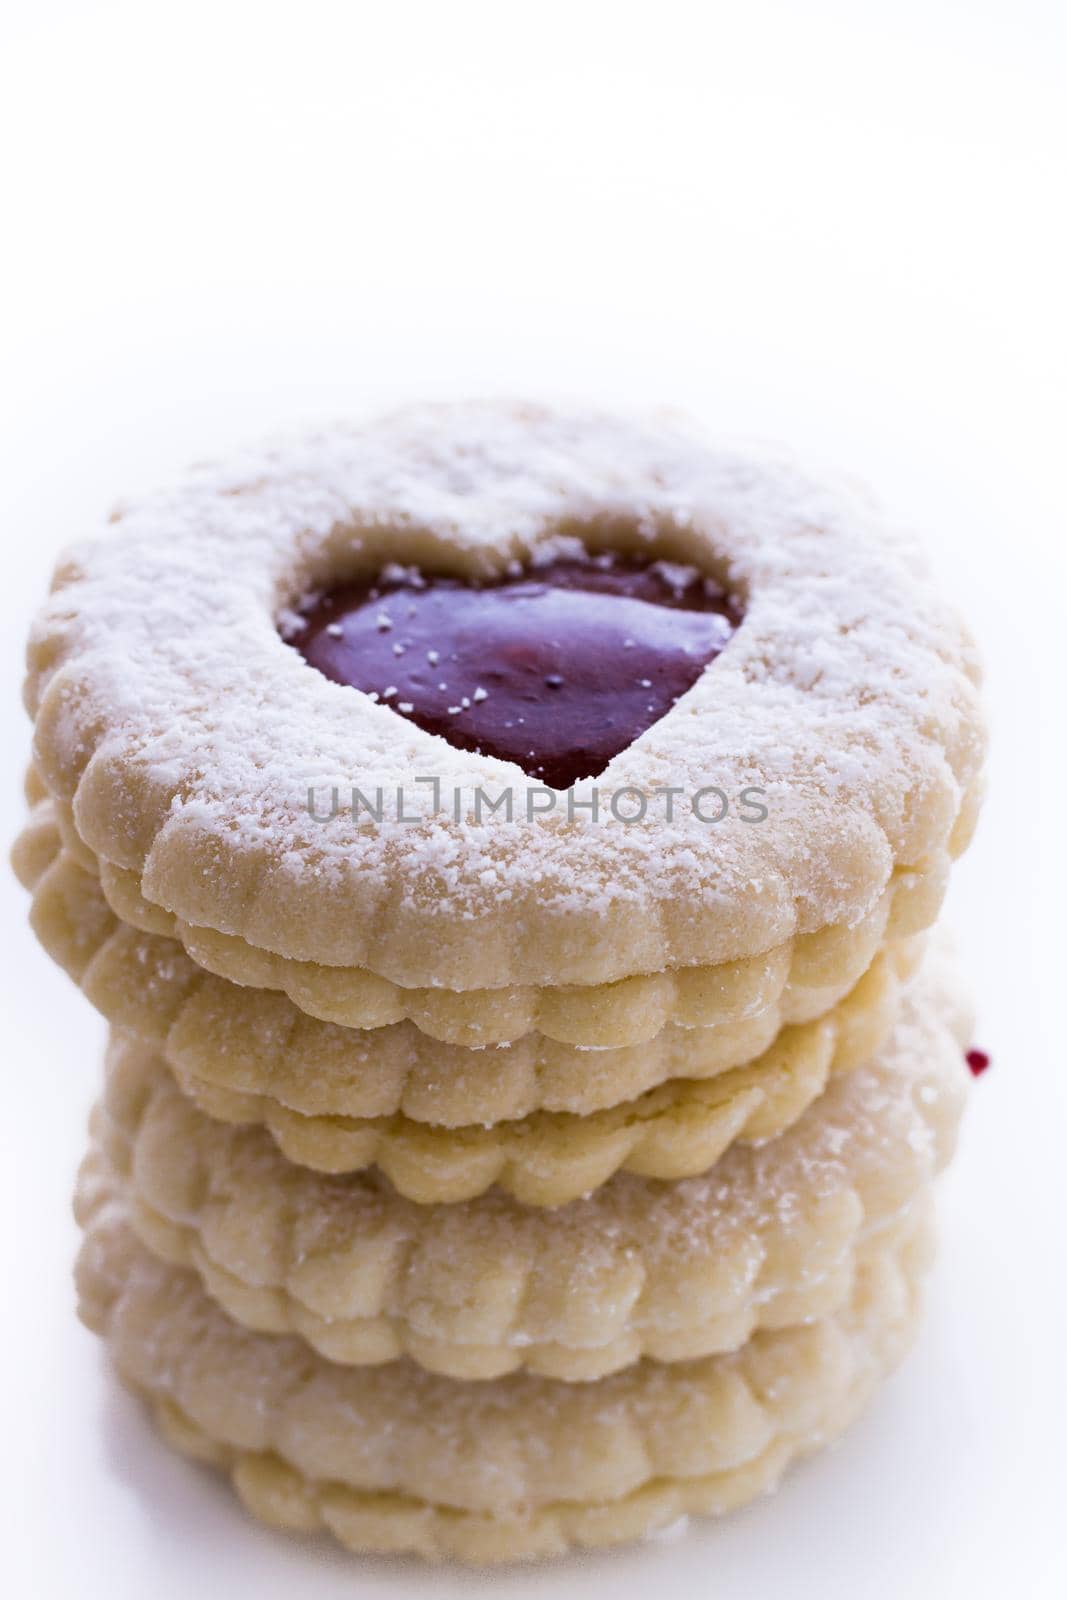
[81,934,921,1206]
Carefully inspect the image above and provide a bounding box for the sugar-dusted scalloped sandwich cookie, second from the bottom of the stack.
[78,963,969,1379]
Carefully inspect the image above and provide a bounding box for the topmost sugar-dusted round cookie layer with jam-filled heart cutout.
[27,403,984,990]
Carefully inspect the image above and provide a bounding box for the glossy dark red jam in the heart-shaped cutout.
[286,555,741,789]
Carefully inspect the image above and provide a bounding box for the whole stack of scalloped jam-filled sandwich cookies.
[14,405,984,1562]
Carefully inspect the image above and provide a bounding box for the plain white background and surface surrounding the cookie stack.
[0,0,1067,1600]
